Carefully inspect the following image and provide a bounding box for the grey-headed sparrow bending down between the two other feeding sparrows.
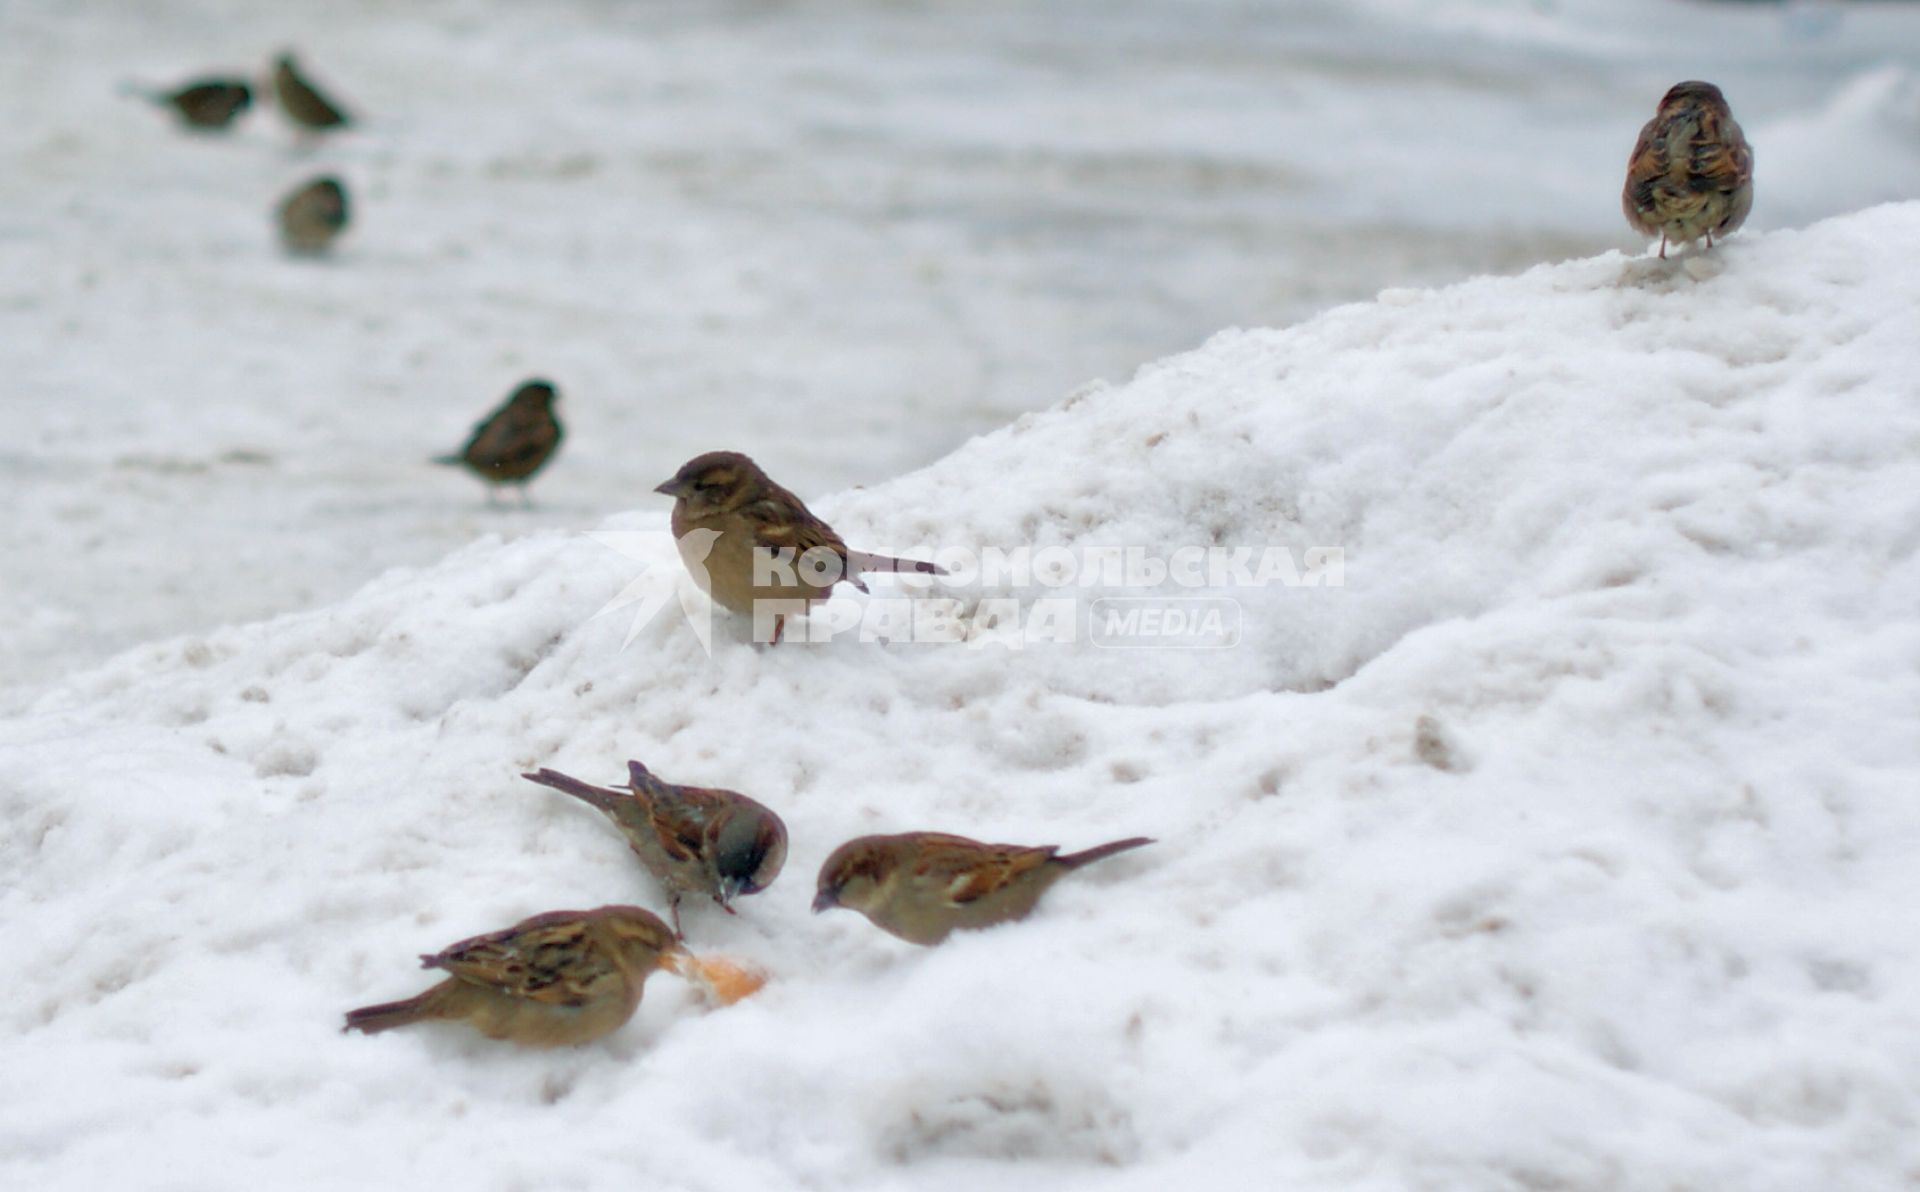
[520,762,787,937]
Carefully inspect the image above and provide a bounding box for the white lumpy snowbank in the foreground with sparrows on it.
[0,203,1920,1192]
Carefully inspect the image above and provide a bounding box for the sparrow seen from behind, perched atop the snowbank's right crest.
[1620,83,1753,259]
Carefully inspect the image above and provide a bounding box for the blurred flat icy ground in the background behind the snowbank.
[11,0,1920,708]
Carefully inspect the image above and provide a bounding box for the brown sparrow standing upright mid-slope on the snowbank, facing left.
[653,451,947,645]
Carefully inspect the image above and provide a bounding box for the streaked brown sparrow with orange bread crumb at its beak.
[344,906,682,1048]
